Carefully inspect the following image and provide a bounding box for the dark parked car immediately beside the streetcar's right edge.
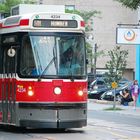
[88,78,110,100]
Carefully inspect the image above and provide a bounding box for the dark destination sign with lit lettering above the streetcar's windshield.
[33,19,78,28]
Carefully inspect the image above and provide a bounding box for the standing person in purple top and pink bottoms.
[131,80,140,109]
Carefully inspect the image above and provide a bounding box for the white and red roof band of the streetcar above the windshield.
[0,12,84,34]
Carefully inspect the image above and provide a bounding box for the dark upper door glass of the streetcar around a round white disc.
[0,34,18,76]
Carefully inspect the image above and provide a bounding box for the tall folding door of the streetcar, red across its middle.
[1,46,17,123]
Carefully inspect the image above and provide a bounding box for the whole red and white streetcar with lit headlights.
[0,13,87,129]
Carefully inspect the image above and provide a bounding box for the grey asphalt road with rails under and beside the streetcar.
[0,103,140,140]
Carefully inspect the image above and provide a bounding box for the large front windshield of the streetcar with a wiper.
[20,33,86,77]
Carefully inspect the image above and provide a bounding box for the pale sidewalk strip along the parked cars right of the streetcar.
[88,99,140,117]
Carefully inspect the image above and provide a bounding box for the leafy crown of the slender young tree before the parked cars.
[105,46,128,85]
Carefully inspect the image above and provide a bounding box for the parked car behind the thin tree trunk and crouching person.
[101,82,132,101]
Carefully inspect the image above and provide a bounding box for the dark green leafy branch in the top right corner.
[115,0,140,10]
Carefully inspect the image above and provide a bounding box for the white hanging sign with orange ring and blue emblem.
[116,26,140,45]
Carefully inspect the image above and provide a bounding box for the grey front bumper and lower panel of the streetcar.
[17,103,87,128]
